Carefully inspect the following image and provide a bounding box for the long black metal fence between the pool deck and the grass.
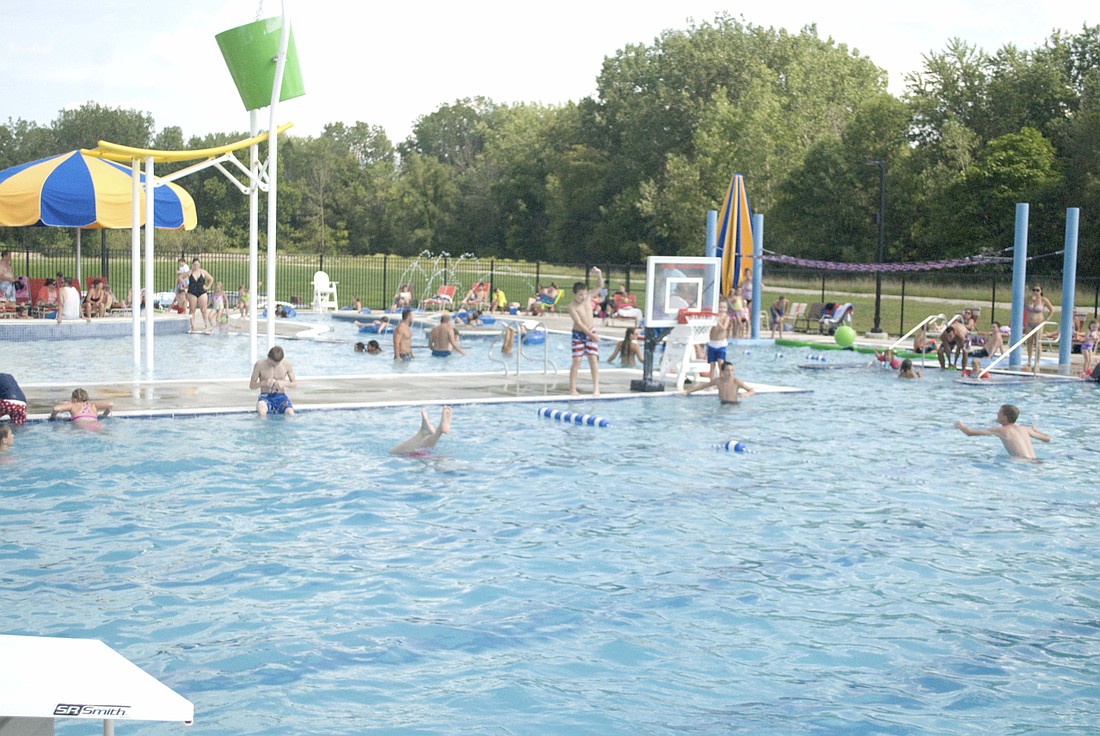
[12,245,1100,331]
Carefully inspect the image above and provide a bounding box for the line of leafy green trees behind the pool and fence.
[0,14,1100,275]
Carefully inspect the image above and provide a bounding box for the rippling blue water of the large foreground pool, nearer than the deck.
[0,347,1100,736]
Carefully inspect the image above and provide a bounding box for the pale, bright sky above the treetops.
[0,0,1100,146]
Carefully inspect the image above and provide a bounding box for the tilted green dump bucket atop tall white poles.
[215,18,306,110]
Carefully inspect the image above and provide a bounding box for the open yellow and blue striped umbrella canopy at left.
[0,151,198,230]
